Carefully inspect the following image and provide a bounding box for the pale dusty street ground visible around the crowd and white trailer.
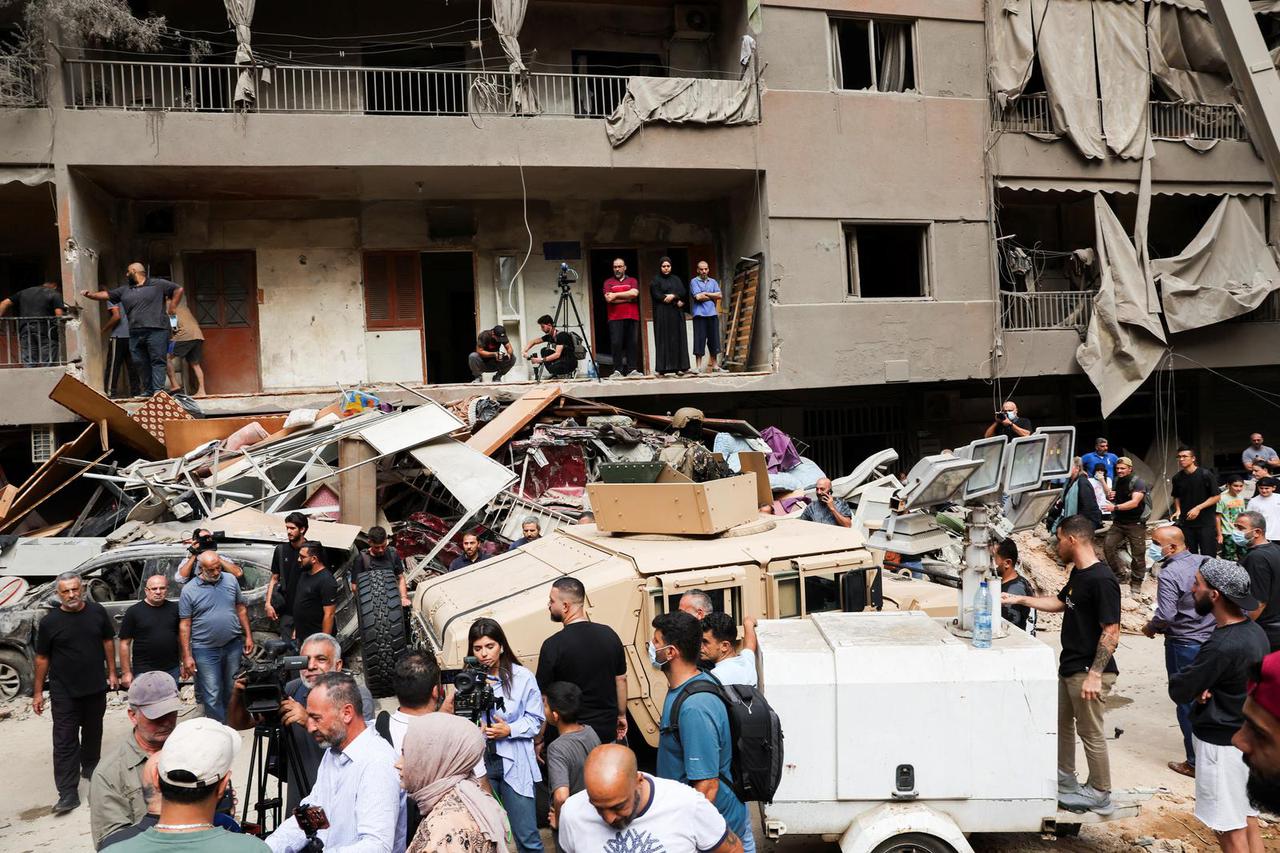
[0,622,1280,853]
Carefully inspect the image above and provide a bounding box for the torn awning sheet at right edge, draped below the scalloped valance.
[1151,196,1280,332]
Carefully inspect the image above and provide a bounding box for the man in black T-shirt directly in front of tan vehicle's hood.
[536,578,627,743]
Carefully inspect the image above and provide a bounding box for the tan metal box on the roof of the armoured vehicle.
[586,474,759,534]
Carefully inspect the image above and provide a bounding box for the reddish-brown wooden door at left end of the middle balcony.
[183,252,262,394]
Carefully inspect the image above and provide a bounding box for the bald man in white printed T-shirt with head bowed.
[558,744,742,853]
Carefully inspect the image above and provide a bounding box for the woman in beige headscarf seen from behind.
[396,713,508,853]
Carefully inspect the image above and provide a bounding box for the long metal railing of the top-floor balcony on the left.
[64,59,742,118]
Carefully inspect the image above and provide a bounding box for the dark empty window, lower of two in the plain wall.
[845,223,929,300]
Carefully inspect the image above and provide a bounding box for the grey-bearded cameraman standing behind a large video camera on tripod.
[227,634,376,813]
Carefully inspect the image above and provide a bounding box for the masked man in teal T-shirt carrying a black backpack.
[649,611,755,853]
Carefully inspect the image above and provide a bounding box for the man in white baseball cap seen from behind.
[111,717,268,853]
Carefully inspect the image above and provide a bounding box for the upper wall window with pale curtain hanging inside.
[831,18,915,92]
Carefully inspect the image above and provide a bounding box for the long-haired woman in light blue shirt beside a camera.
[467,619,544,853]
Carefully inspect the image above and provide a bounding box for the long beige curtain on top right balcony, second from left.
[1032,0,1107,160]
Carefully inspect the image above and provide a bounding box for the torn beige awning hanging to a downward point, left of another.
[1075,196,1165,418]
